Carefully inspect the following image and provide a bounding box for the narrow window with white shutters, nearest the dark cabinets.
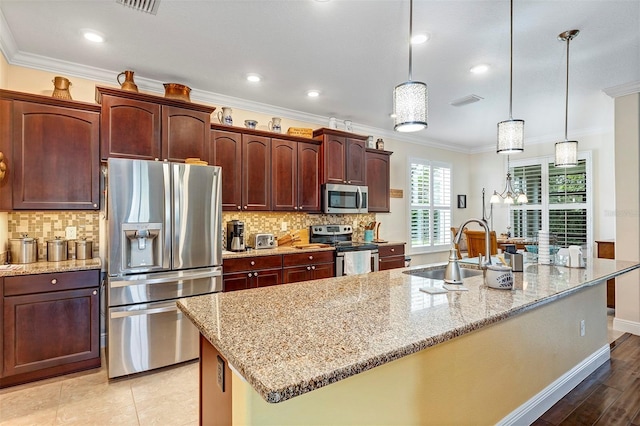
[409,158,452,251]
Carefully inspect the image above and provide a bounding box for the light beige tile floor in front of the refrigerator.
[0,310,624,426]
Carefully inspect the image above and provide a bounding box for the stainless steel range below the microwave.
[309,225,378,277]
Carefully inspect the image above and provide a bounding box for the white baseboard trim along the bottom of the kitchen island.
[497,344,611,425]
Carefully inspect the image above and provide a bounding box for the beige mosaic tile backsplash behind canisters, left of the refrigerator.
[7,211,100,260]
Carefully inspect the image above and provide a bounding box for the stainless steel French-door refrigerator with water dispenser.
[107,158,222,378]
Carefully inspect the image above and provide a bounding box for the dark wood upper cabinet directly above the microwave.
[313,128,367,185]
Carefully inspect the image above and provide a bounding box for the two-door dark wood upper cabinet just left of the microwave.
[271,139,320,212]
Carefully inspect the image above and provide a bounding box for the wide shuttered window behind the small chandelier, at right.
[510,153,593,247]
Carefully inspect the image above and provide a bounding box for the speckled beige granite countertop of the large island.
[178,259,640,403]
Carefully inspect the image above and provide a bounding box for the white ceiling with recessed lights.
[0,0,640,152]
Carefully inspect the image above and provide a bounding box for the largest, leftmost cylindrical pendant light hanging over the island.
[393,0,428,132]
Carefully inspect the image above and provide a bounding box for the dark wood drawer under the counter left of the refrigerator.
[4,269,100,296]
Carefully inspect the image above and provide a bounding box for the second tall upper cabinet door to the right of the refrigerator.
[242,135,271,211]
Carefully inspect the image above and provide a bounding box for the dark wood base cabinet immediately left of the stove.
[282,251,335,284]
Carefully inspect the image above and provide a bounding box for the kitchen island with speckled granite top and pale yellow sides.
[178,259,640,424]
